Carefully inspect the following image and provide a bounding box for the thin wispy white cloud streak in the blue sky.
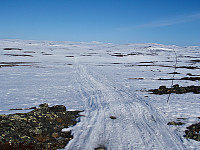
[118,13,200,30]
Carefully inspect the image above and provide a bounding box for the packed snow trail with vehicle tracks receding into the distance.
[66,59,185,150]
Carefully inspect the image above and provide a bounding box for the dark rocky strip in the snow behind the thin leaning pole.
[148,84,200,95]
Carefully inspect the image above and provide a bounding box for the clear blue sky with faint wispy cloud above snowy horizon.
[0,0,200,46]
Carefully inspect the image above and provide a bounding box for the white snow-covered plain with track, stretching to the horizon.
[0,40,200,150]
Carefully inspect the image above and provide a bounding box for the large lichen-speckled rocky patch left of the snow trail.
[0,103,80,150]
